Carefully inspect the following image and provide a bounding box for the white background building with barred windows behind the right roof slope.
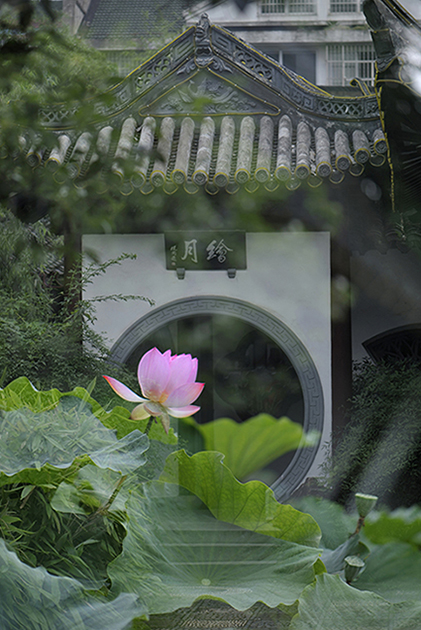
[187,0,374,86]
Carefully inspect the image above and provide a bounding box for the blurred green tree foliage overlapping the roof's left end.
[0,0,131,234]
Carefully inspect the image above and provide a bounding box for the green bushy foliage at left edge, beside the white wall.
[0,210,150,405]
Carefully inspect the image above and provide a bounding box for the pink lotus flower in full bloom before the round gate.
[104,348,204,433]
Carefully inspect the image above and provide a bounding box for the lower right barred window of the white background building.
[327,44,375,85]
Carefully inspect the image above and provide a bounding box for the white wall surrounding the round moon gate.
[83,232,331,476]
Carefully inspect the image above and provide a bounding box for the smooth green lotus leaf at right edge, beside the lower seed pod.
[353,543,421,604]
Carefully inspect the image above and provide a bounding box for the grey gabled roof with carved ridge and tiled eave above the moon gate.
[28,15,387,194]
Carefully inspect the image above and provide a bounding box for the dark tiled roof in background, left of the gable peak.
[81,0,186,44]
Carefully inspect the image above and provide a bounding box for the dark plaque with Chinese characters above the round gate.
[165,230,246,270]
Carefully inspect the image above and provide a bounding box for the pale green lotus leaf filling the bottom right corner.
[289,573,421,630]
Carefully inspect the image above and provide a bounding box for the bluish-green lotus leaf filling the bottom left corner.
[0,540,146,630]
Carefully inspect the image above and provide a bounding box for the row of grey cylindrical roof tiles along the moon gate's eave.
[28,114,387,195]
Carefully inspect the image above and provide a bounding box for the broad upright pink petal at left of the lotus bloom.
[137,348,171,401]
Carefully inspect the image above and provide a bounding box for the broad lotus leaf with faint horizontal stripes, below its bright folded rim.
[108,481,319,613]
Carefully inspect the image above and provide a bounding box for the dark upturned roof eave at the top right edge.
[363,0,421,212]
